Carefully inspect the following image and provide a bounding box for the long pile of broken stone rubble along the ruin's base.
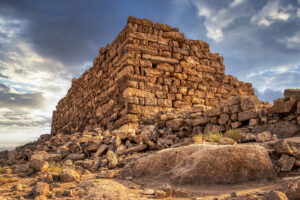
[0,90,300,176]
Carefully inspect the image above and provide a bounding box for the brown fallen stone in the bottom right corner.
[282,179,300,199]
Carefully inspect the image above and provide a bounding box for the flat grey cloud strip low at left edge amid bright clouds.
[0,84,45,109]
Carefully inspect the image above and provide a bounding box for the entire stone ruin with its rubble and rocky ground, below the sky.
[0,17,300,200]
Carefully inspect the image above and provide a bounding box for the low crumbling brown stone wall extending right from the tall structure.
[162,89,300,138]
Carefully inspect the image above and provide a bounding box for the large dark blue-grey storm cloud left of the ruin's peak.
[0,0,173,75]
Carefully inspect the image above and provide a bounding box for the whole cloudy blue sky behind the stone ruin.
[0,0,300,148]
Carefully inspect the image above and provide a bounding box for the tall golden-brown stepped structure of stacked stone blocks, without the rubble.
[51,17,254,134]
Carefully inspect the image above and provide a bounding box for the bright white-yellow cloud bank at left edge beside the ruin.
[0,15,71,148]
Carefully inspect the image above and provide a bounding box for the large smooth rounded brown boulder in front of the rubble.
[121,144,277,184]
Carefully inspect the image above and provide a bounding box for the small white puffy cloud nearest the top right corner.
[251,1,291,26]
